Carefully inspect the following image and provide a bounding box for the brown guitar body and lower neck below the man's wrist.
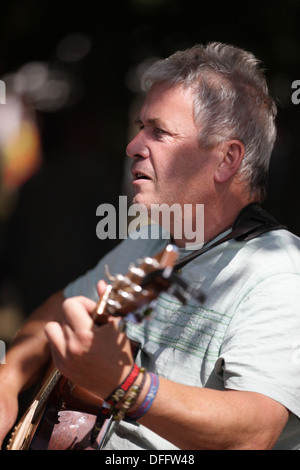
[7,370,109,450]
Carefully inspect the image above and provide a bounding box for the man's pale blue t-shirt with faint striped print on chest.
[65,230,300,450]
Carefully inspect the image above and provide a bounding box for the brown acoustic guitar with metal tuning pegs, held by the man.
[7,245,203,450]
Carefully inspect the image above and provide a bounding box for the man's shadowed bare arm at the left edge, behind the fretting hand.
[0,291,64,445]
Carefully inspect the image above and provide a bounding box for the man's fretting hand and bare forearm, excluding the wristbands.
[46,299,288,449]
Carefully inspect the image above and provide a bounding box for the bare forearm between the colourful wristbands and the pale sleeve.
[140,379,289,450]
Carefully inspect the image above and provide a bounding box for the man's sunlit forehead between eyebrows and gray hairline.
[140,83,195,126]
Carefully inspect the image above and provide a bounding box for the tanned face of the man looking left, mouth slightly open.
[127,84,218,209]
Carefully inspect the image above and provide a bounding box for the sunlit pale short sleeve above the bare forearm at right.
[215,273,300,417]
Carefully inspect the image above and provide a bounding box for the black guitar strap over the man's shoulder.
[175,203,287,271]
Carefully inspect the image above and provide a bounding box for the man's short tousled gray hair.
[142,42,277,201]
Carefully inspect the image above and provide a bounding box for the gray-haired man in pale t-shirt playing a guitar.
[0,43,300,449]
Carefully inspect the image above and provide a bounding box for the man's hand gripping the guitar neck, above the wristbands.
[45,282,133,398]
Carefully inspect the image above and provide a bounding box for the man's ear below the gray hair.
[215,140,245,183]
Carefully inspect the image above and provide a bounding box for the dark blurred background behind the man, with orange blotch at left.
[0,0,300,340]
